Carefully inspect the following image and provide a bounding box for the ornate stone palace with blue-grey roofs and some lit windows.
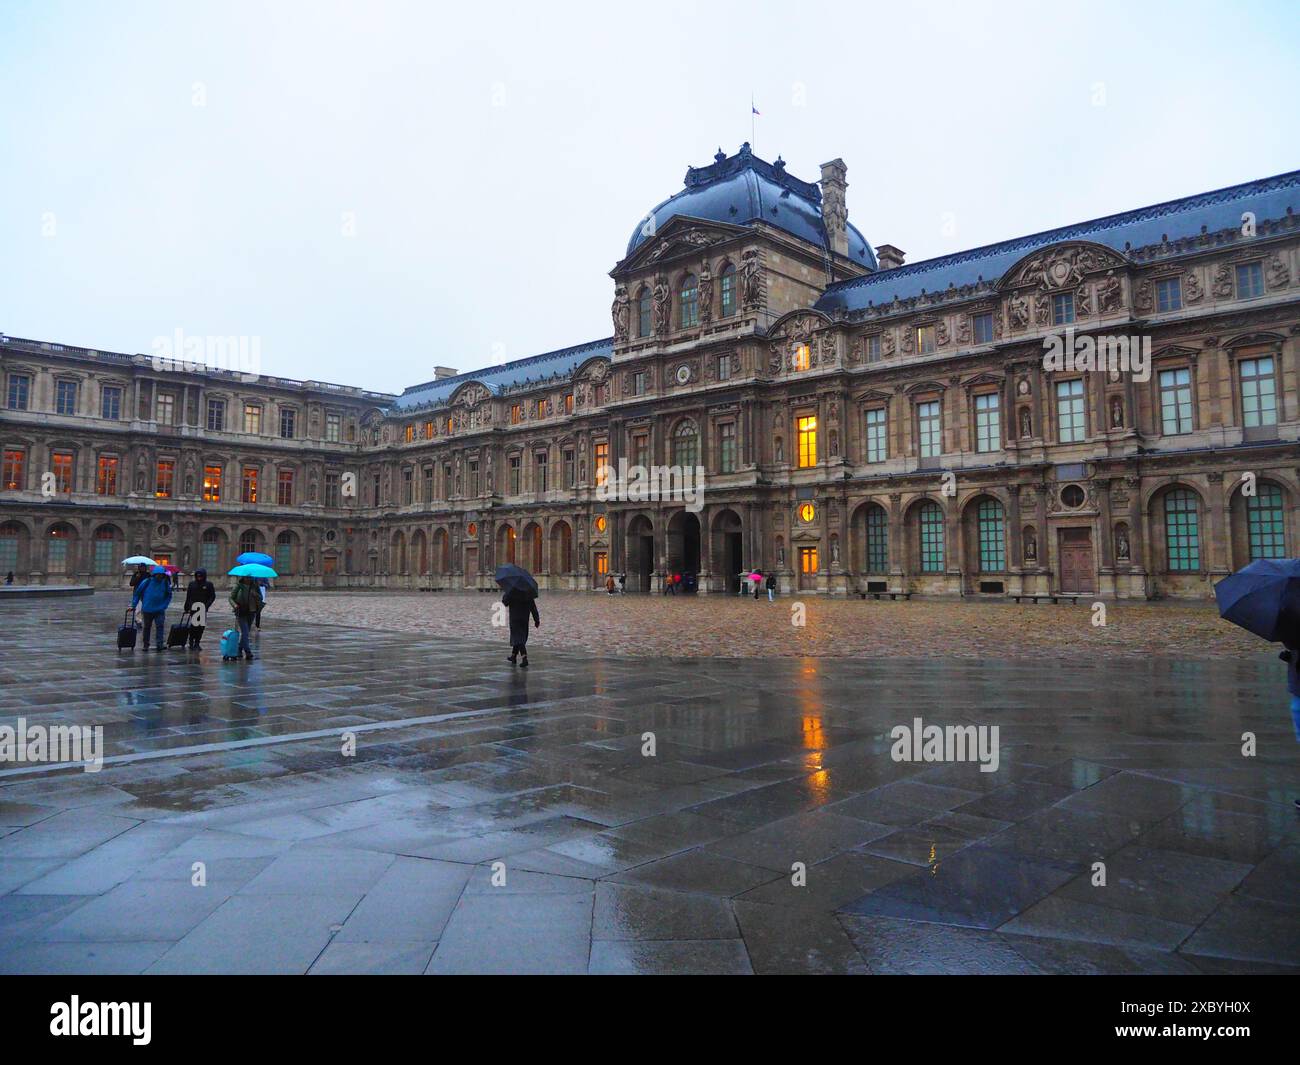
[0,146,1300,598]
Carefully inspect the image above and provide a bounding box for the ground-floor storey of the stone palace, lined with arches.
[0,471,1300,598]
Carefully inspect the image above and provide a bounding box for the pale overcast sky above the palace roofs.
[0,0,1300,391]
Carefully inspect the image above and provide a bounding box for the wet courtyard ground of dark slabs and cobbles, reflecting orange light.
[0,593,1300,974]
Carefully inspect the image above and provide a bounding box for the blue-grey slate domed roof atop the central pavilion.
[627,143,876,269]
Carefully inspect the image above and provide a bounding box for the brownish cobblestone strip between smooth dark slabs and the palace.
[270,592,1262,658]
